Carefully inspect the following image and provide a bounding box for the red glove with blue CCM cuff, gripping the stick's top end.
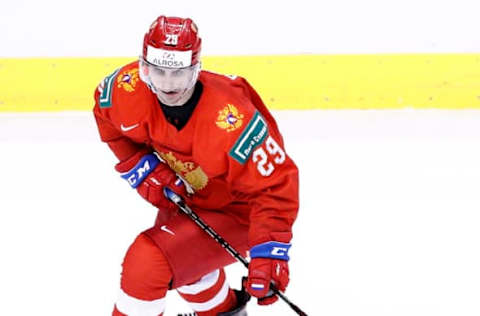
[115,152,186,211]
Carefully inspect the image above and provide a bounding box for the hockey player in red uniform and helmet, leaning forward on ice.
[94,16,298,316]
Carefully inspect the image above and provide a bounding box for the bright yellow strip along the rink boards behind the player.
[0,54,480,112]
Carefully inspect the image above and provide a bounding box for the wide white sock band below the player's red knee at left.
[115,289,165,316]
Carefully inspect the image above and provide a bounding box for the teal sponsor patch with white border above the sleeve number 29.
[230,111,268,165]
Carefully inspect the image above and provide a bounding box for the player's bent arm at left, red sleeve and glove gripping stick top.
[93,85,185,211]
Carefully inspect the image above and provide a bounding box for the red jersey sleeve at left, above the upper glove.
[93,77,145,161]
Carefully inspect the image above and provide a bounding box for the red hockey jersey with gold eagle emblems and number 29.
[94,62,298,246]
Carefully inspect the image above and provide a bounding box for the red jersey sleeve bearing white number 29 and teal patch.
[228,85,299,246]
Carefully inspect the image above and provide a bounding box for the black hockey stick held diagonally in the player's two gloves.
[163,187,307,316]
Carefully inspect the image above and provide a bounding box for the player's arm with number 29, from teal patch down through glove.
[230,112,298,304]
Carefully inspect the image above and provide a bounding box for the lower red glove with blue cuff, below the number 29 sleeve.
[247,241,291,305]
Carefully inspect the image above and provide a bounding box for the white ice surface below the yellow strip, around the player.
[0,110,480,316]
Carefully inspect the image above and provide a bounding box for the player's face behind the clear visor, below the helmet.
[140,59,200,106]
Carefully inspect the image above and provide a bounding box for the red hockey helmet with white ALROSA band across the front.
[142,15,202,68]
